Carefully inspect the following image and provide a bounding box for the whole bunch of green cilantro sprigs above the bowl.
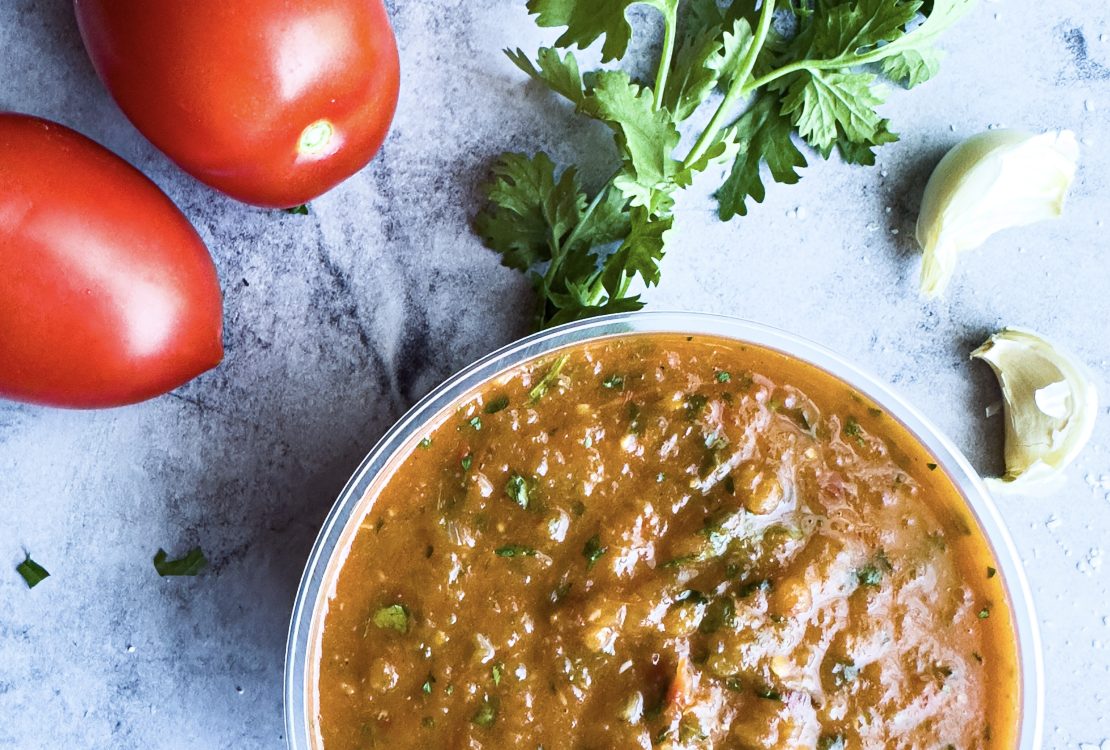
[475,0,975,327]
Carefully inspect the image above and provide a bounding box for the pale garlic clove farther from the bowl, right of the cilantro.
[917,130,1079,297]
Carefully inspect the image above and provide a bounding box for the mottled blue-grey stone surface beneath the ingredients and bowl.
[0,0,1110,750]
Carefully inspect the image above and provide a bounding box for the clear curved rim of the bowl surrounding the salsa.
[284,313,1045,750]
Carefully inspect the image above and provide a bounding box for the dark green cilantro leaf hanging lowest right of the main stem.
[717,93,807,221]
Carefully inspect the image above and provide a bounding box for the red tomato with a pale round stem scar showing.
[74,0,400,207]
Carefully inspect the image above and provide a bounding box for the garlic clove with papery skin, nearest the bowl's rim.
[971,328,1099,495]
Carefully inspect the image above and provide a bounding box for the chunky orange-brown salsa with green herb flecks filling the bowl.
[315,334,1019,750]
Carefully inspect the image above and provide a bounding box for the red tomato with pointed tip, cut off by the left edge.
[0,112,223,408]
